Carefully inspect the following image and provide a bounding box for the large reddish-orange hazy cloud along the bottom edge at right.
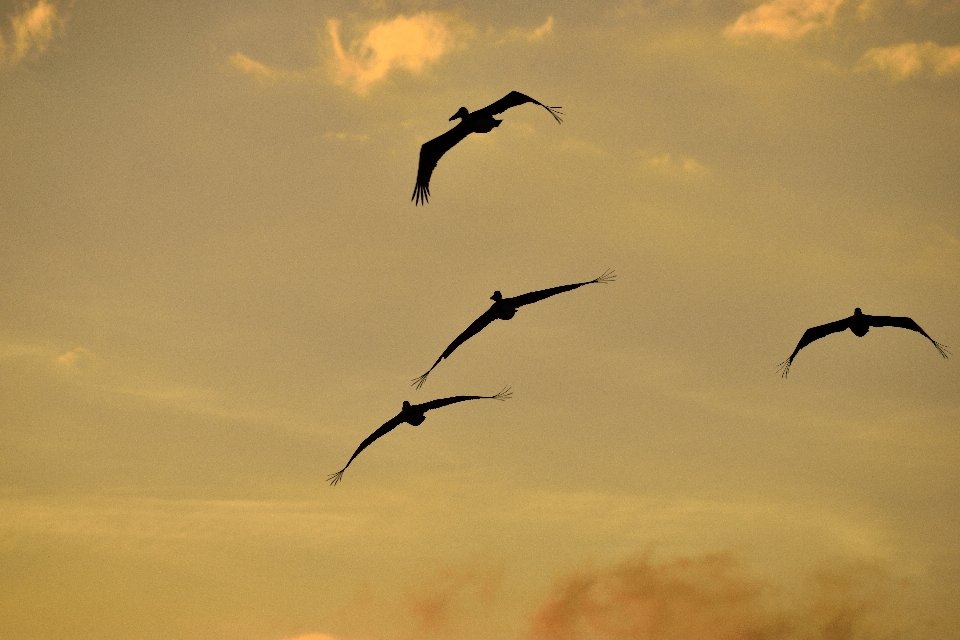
[530,554,900,640]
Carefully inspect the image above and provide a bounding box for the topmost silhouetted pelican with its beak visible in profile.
[410,91,563,204]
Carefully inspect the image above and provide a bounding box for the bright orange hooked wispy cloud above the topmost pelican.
[327,12,457,94]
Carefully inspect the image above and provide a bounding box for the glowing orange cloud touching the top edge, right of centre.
[724,0,843,40]
